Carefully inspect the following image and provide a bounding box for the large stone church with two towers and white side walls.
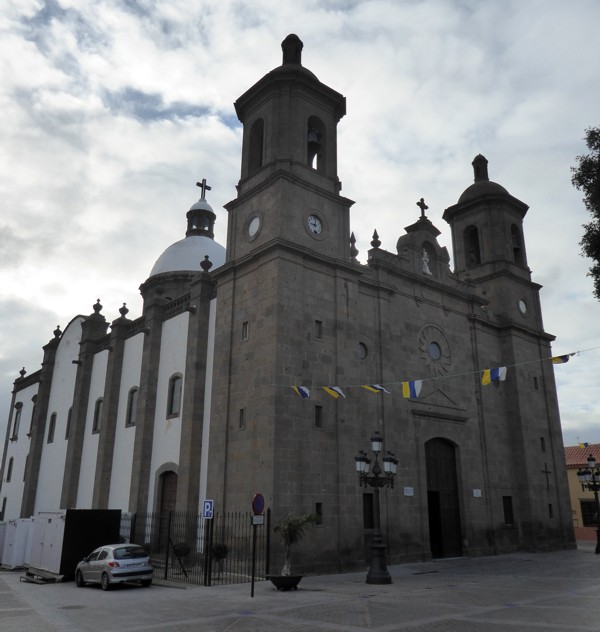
[0,35,574,572]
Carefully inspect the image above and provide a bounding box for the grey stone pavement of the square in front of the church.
[0,543,600,632]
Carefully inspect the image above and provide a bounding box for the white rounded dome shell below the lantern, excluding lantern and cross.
[150,235,225,277]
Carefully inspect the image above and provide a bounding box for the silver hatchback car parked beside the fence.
[75,544,153,590]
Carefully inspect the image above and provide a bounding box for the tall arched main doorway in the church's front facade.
[425,439,462,557]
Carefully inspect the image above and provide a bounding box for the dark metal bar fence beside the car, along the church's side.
[121,510,271,586]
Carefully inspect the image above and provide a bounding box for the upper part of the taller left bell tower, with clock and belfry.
[226,35,352,261]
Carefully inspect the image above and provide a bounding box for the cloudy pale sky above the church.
[0,0,600,444]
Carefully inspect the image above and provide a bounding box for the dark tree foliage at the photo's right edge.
[571,127,600,300]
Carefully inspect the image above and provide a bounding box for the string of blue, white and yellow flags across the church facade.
[282,346,600,399]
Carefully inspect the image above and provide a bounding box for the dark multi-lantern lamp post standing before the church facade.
[354,432,398,584]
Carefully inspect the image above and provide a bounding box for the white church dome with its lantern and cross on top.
[150,185,225,277]
